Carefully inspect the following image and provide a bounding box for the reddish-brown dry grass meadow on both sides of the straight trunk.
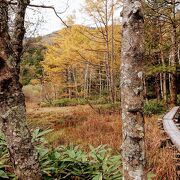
[27,105,175,180]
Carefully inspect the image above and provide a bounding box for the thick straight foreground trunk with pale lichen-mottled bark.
[121,0,145,180]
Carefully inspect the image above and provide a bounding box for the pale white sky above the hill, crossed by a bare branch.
[26,0,85,35]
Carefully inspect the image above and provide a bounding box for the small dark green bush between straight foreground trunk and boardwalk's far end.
[144,100,166,116]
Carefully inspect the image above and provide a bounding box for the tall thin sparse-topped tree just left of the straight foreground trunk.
[85,0,119,103]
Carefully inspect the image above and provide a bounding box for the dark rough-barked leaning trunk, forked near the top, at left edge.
[0,0,41,180]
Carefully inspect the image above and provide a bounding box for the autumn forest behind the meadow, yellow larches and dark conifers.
[21,1,180,108]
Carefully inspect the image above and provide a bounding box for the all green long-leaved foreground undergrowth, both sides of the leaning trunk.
[0,129,122,180]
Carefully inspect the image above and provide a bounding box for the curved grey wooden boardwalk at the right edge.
[163,106,180,152]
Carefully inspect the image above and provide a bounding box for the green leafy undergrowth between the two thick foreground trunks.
[41,145,121,180]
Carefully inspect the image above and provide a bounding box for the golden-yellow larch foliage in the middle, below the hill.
[42,25,120,98]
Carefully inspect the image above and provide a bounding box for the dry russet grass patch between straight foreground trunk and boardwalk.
[145,116,175,180]
